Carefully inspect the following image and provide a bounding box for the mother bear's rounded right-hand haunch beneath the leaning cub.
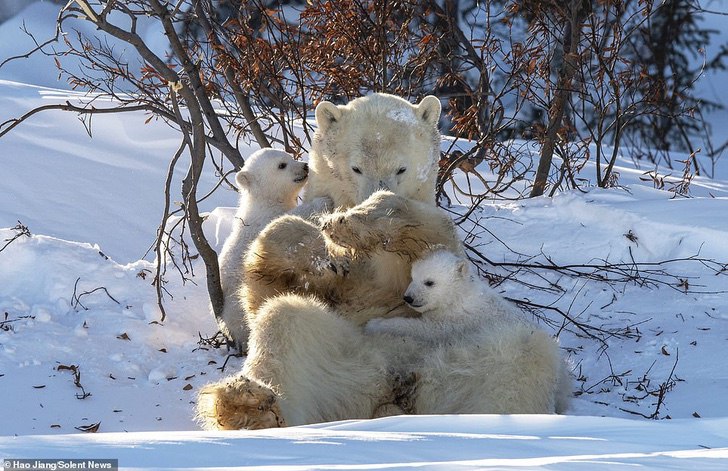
[414,324,570,414]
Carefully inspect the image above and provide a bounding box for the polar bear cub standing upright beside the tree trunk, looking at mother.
[217,149,308,351]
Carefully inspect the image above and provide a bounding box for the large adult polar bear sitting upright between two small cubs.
[198,94,568,428]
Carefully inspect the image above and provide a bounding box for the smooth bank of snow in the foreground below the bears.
[0,415,728,471]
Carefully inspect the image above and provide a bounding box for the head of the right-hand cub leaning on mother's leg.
[404,250,471,313]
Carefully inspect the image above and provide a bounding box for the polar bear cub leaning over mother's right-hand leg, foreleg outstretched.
[366,250,528,342]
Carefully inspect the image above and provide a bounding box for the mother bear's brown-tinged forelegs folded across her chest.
[242,191,462,325]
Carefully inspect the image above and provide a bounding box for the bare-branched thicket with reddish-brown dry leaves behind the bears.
[0,0,728,336]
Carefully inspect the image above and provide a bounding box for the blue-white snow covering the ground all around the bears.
[0,2,728,470]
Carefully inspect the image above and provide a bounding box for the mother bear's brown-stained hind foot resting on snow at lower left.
[197,376,286,430]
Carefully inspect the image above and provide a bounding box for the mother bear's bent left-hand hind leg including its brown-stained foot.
[197,295,416,429]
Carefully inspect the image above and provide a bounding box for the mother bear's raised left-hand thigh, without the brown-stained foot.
[243,295,396,425]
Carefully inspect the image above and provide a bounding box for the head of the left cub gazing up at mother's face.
[235,148,308,207]
